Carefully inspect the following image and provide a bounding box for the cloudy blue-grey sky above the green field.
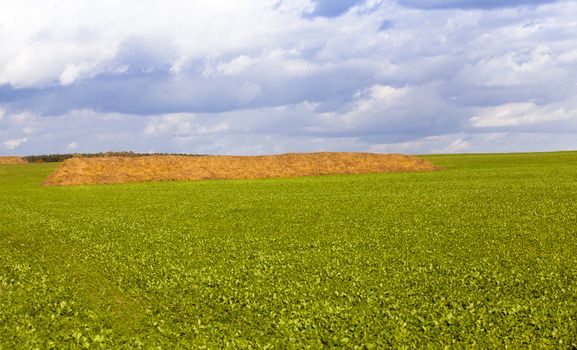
[0,0,577,155]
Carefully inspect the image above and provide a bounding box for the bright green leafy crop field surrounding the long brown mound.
[0,152,577,349]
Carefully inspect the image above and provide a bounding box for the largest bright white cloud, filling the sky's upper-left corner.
[0,0,320,87]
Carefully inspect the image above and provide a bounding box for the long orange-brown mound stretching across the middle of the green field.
[44,153,435,186]
